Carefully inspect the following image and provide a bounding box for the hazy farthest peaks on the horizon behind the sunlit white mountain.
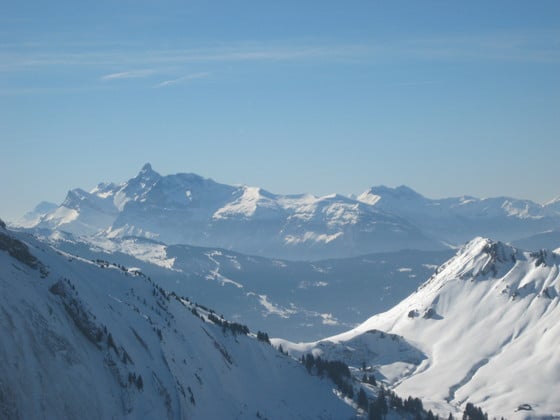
[358,186,560,244]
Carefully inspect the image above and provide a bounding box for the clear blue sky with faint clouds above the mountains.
[0,0,560,219]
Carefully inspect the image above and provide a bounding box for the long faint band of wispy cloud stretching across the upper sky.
[0,30,560,74]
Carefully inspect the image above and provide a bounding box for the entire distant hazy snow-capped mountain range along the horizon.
[20,164,560,260]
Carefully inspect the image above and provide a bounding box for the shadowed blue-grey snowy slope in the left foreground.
[0,227,355,419]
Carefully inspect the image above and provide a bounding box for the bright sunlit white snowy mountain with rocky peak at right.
[283,238,560,418]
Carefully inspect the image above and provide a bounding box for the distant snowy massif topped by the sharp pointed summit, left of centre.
[29,164,444,259]
